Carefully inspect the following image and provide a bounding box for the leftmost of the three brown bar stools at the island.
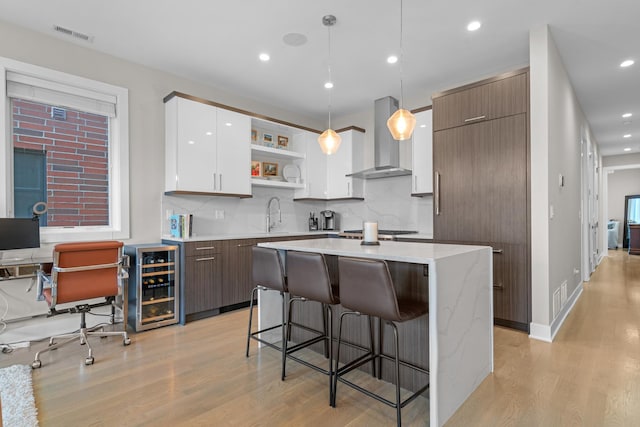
[246,246,288,379]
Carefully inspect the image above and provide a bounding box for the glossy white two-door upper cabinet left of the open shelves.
[165,96,251,196]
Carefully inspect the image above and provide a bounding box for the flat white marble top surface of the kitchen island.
[258,238,491,264]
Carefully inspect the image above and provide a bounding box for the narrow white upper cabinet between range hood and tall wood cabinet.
[411,109,433,196]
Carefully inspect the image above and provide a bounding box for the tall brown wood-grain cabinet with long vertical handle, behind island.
[433,69,531,331]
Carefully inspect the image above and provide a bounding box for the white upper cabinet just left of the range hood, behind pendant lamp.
[320,129,364,199]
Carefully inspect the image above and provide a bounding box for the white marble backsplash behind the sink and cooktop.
[161,176,433,236]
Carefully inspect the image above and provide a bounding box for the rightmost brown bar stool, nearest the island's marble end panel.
[332,257,429,426]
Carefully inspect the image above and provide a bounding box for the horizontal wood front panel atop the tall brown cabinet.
[433,73,529,131]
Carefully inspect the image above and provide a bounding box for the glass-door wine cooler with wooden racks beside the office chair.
[124,244,180,331]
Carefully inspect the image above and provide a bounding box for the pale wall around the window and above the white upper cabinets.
[0,21,323,247]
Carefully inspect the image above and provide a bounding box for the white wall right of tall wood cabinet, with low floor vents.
[530,26,590,340]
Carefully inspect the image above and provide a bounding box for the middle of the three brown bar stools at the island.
[282,251,340,404]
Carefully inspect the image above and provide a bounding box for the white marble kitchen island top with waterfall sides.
[258,239,493,426]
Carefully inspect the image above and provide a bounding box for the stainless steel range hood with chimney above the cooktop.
[347,96,411,179]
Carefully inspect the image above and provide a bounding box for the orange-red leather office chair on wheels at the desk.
[31,241,131,369]
